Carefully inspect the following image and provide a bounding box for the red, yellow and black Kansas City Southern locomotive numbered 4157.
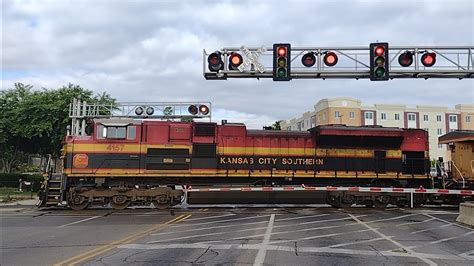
[42,118,450,209]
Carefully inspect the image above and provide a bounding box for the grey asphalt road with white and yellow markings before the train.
[0,206,474,265]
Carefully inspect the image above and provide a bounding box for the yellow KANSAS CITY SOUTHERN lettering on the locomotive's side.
[219,156,324,165]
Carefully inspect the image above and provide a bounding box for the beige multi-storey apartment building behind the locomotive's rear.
[281,97,474,160]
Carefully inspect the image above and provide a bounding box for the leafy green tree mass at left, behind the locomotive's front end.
[0,83,116,172]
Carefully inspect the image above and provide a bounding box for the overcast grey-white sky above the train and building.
[1,0,474,128]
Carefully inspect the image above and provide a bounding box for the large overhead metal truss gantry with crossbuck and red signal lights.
[203,42,474,81]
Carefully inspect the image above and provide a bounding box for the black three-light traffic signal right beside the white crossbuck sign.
[273,43,291,81]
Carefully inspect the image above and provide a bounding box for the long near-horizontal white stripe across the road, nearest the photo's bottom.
[118,243,474,261]
